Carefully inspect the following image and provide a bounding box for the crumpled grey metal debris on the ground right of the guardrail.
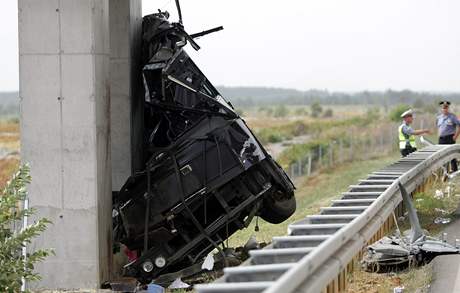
[362,183,460,273]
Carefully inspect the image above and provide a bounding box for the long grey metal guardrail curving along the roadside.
[195,145,460,293]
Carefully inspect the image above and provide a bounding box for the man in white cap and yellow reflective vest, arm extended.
[398,109,430,157]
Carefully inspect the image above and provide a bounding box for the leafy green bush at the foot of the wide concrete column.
[0,166,53,293]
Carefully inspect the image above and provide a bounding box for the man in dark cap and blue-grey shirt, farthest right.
[436,101,460,172]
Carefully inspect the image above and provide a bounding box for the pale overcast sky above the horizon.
[0,0,460,91]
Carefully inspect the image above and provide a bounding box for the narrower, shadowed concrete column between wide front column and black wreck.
[109,0,143,191]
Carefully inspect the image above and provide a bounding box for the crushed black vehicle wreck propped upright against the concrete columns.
[113,3,296,281]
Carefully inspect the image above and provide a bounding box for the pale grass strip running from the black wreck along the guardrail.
[229,156,398,247]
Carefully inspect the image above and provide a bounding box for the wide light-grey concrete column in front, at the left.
[18,0,112,289]
